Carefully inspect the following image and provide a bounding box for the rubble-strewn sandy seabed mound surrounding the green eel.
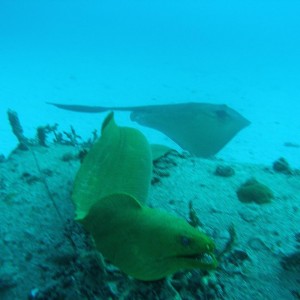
[0,144,300,300]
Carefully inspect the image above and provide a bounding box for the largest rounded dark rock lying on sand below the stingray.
[236,178,274,204]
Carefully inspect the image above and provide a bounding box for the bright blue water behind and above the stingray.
[0,0,300,167]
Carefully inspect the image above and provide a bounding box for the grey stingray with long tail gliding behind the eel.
[49,102,250,157]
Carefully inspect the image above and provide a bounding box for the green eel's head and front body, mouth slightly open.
[81,194,217,281]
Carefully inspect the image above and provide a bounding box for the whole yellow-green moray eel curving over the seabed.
[73,113,217,281]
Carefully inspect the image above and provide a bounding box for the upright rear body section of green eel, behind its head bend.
[72,113,152,220]
